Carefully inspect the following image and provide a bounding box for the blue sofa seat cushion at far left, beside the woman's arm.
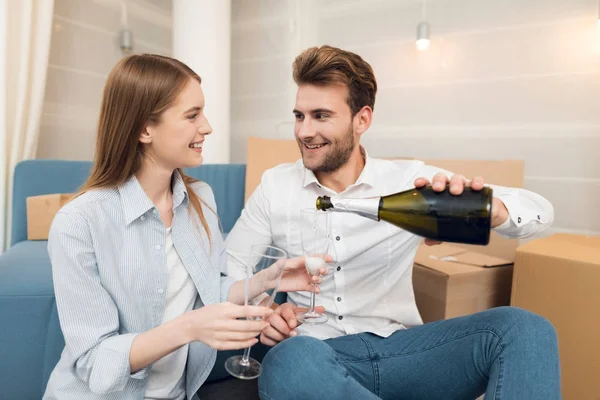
[0,241,64,399]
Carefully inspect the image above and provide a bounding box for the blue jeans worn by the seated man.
[258,307,561,400]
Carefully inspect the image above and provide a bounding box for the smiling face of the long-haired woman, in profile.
[140,79,212,170]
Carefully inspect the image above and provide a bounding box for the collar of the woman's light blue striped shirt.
[119,170,188,225]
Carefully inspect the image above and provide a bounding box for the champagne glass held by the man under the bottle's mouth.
[296,208,331,324]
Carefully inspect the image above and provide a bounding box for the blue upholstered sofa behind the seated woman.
[0,160,268,400]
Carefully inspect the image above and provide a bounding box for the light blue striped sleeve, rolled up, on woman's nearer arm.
[48,212,147,393]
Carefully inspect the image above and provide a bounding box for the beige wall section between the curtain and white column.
[37,0,172,160]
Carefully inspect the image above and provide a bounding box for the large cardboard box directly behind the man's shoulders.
[246,137,525,261]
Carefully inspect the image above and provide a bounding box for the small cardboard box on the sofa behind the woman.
[26,193,75,240]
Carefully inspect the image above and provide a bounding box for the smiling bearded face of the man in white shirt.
[294,84,359,173]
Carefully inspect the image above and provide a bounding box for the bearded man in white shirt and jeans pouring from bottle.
[227,46,560,400]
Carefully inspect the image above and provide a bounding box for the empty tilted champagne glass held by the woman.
[225,245,288,379]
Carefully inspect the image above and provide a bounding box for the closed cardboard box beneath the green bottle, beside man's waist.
[413,243,513,323]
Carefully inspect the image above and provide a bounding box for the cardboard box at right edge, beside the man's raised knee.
[511,234,600,400]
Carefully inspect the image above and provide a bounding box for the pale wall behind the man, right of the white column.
[231,0,600,235]
